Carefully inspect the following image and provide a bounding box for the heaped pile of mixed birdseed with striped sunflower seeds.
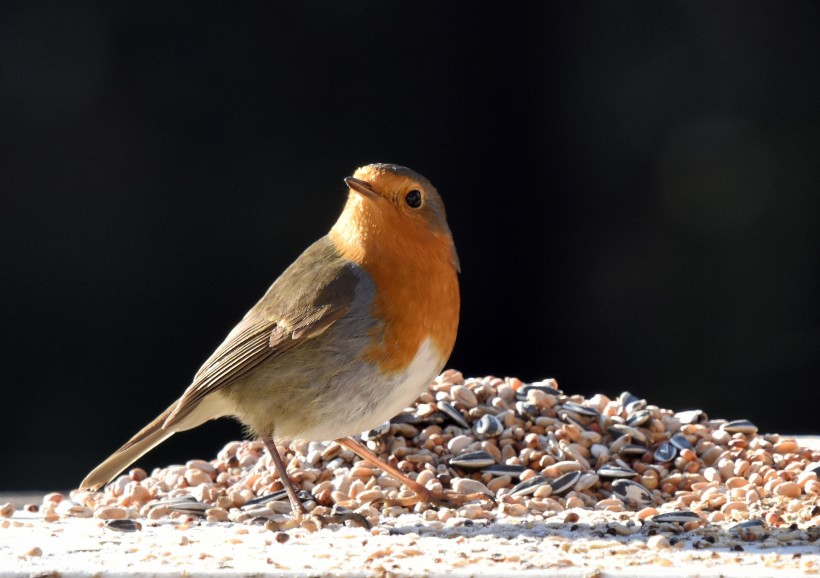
[0,370,820,571]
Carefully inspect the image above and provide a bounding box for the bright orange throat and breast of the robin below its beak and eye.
[330,198,460,373]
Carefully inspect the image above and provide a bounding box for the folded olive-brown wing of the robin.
[164,237,358,427]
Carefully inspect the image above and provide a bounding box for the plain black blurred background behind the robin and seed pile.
[0,0,820,490]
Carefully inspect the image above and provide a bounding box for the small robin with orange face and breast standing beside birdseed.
[80,164,470,520]
